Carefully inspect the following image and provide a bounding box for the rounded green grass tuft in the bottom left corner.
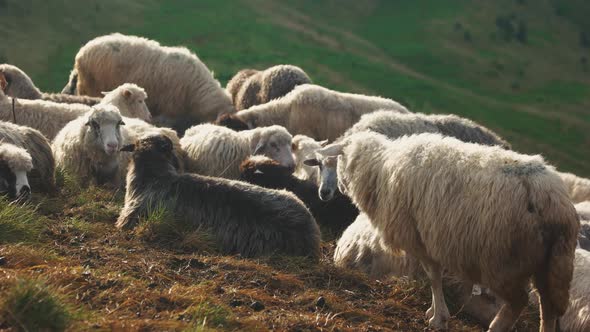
[0,279,74,331]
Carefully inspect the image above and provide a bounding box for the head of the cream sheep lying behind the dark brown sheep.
[252,126,295,171]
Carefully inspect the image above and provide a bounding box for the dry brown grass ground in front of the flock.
[0,180,538,331]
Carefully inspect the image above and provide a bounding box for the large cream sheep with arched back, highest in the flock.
[61,33,235,133]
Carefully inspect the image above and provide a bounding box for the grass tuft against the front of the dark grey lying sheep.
[135,204,216,252]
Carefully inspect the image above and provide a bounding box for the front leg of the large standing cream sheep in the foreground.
[422,262,451,330]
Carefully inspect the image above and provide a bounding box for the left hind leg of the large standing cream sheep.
[488,287,528,332]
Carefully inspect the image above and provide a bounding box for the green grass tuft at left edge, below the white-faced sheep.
[0,197,45,244]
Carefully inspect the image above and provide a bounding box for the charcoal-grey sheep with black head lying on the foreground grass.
[116,135,320,260]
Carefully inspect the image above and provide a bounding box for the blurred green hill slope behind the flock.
[0,0,590,176]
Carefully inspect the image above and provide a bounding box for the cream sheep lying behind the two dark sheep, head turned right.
[180,124,295,179]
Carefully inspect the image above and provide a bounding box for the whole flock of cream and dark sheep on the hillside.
[0,34,590,331]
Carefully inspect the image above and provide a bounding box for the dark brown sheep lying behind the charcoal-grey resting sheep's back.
[239,156,359,234]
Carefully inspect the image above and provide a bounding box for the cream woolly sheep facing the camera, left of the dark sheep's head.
[52,104,129,187]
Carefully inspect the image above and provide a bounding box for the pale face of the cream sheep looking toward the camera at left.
[86,110,125,156]
